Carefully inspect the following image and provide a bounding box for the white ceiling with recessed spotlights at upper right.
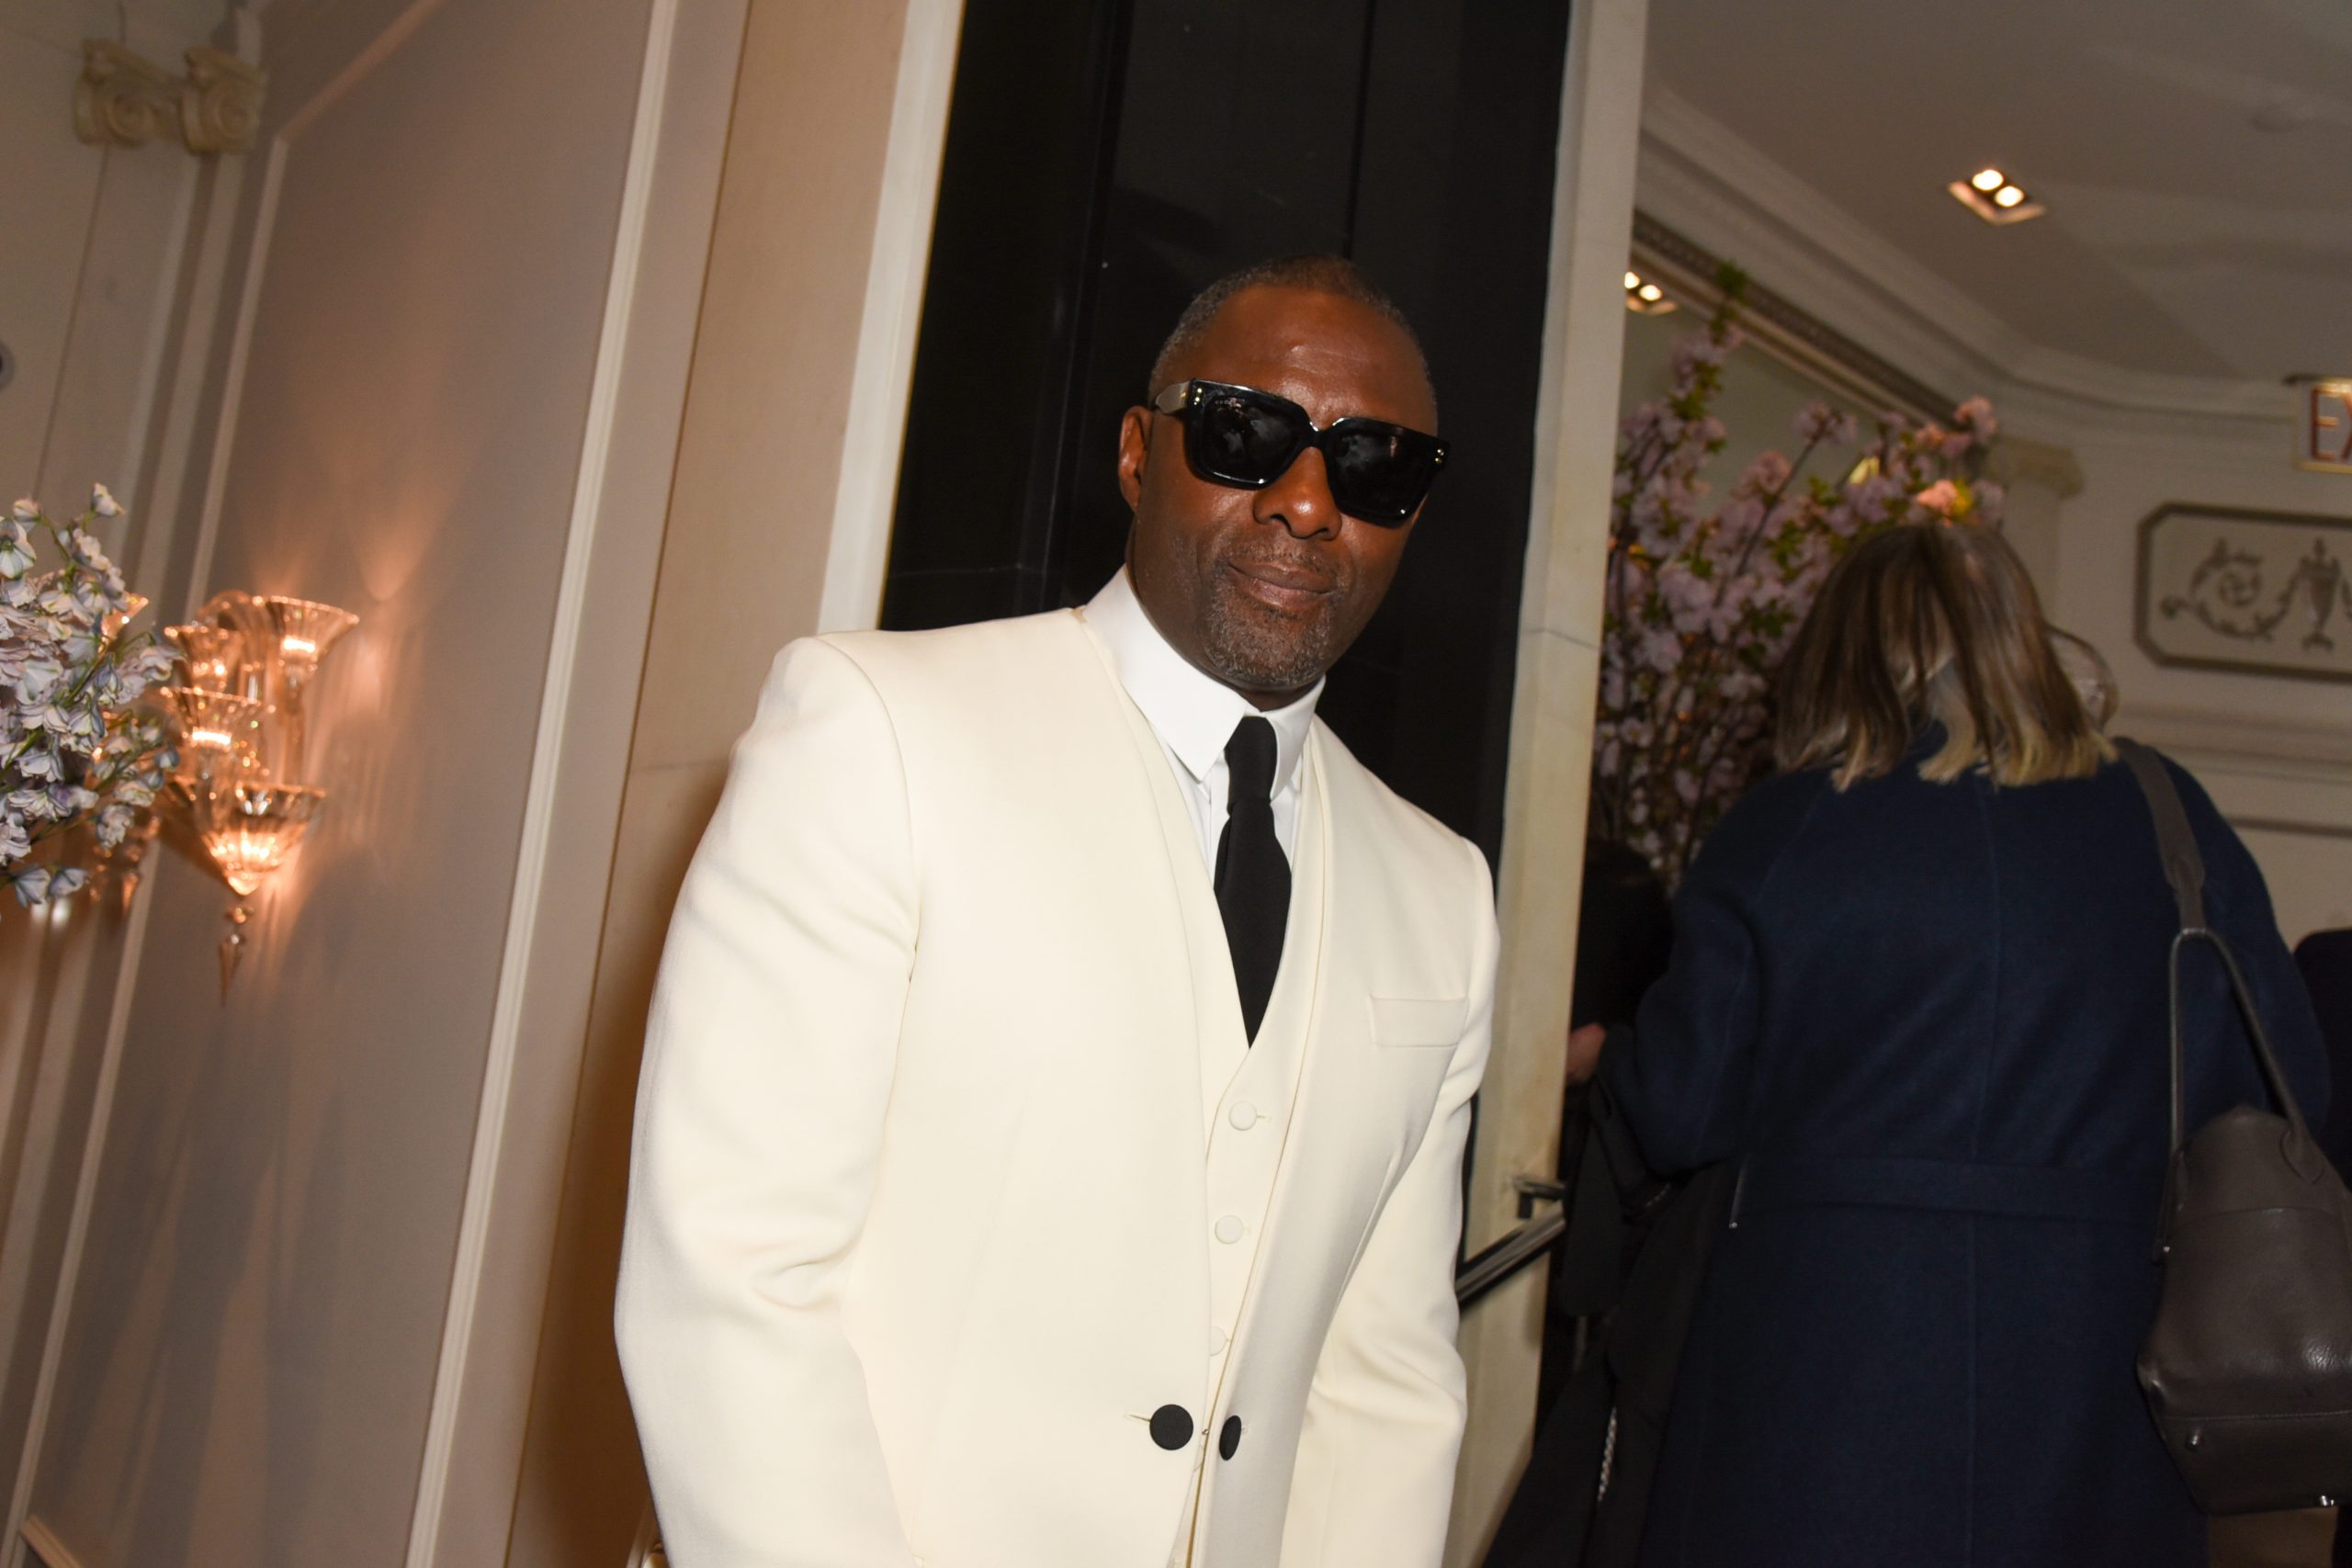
[1649,0,2352,383]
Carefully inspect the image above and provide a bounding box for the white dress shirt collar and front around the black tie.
[1087,567,1322,877]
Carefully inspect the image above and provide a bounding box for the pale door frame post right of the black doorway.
[1444,0,1649,1568]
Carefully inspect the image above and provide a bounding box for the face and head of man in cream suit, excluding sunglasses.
[1120,287,1437,707]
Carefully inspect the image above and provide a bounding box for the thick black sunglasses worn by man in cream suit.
[1152,381,1446,529]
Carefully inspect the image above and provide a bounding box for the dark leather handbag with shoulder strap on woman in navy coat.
[2117,740,2352,1514]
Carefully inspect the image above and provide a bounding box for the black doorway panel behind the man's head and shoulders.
[882,0,1569,861]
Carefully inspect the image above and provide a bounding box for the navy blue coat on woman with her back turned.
[1606,752,2328,1568]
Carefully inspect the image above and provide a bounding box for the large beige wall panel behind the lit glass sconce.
[33,0,647,1568]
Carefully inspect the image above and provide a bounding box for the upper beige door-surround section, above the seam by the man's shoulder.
[633,0,936,764]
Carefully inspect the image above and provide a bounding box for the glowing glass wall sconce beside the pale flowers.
[160,590,360,997]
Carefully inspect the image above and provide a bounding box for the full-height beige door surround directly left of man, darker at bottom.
[508,0,953,1568]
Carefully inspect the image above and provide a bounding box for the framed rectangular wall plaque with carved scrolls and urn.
[2138,503,2352,680]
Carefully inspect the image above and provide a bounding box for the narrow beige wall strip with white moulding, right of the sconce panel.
[412,0,746,1563]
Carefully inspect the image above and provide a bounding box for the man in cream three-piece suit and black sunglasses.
[618,256,1496,1568]
